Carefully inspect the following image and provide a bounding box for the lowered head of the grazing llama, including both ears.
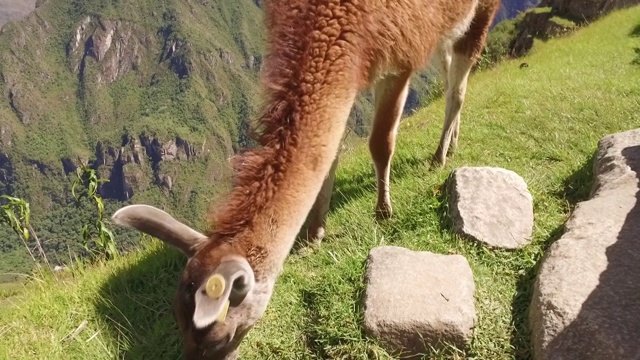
[113,205,273,360]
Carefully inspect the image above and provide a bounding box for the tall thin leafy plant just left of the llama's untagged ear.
[71,164,118,259]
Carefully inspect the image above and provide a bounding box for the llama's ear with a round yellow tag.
[193,256,255,329]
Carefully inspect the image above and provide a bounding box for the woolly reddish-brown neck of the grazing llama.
[206,0,361,271]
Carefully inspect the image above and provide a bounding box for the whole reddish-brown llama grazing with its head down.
[113,0,500,359]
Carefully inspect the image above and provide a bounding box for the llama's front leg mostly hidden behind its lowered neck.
[307,154,339,244]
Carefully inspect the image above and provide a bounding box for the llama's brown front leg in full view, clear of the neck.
[369,72,411,219]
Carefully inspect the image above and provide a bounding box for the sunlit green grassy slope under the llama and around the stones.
[0,7,640,359]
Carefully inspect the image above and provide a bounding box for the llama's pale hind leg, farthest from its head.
[433,52,474,166]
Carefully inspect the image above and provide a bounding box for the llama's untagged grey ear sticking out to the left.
[111,205,207,257]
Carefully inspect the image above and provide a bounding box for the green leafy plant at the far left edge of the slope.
[0,195,51,268]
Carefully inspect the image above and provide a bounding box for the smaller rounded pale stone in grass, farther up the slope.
[447,167,533,249]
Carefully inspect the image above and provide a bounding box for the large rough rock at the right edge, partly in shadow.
[529,129,640,360]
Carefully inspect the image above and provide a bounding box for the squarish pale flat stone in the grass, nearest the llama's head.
[364,246,476,356]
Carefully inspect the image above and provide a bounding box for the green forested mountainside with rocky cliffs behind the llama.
[0,0,440,273]
